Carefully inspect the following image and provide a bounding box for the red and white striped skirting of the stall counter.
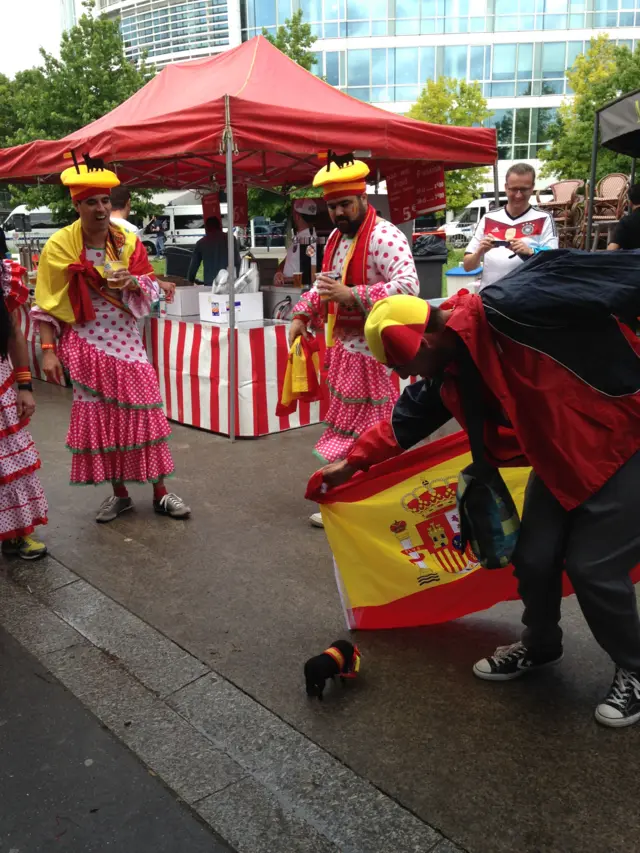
[21,310,404,438]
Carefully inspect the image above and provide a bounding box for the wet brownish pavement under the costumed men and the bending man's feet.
[22,383,640,853]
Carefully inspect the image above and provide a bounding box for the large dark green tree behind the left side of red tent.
[6,0,154,222]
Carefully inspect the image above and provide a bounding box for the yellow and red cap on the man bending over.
[364,295,431,367]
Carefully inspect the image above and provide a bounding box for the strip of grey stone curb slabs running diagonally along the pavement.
[0,556,464,853]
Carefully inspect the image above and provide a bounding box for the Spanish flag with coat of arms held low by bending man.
[307,432,640,629]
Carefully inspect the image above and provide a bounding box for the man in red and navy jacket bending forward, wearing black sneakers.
[323,250,640,728]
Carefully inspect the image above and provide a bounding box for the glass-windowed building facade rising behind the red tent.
[81,0,640,186]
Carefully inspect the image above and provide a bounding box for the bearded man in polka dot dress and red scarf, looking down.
[289,160,419,527]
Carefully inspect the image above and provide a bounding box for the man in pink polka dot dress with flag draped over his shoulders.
[32,166,191,523]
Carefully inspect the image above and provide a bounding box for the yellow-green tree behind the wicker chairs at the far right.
[540,35,640,185]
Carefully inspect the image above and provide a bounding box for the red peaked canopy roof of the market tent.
[0,36,497,187]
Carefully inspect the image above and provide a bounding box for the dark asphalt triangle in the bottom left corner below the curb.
[0,629,232,853]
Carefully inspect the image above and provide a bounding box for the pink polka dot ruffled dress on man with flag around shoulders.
[32,249,174,484]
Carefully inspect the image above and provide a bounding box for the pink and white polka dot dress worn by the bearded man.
[293,220,419,463]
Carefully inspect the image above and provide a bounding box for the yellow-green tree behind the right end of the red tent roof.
[407,77,491,210]
